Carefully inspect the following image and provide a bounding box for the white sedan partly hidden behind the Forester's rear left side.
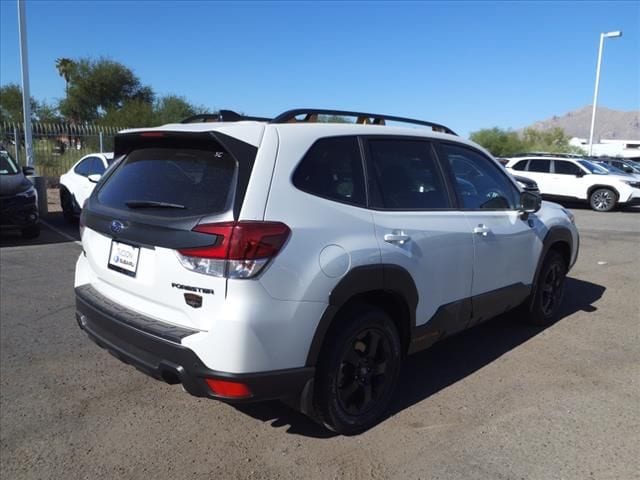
[60,152,113,221]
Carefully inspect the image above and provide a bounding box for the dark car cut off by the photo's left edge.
[0,147,40,238]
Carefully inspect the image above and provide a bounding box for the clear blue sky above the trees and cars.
[0,0,640,135]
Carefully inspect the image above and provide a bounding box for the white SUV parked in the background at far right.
[506,155,640,212]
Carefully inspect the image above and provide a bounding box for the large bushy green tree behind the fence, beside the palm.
[59,58,154,122]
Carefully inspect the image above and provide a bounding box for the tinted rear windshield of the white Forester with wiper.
[98,148,236,216]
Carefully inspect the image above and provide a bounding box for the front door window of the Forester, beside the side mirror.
[442,144,519,210]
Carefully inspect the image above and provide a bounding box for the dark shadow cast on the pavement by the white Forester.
[236,278,606,438]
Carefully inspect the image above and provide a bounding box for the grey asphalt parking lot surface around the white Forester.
[0,204,640,480]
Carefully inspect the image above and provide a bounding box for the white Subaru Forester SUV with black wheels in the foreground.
[75,110,578,434]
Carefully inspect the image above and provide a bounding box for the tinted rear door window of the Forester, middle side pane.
[369,139,451,210]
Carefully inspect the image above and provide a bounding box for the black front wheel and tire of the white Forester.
[520,250,567,326]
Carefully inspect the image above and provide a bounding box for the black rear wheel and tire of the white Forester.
[314,305,402,435]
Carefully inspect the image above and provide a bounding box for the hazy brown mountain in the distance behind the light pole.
[529,105,640,142]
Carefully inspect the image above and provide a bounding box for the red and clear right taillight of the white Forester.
[178,221,291,278]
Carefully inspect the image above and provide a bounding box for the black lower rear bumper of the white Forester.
[76,285,314,403]
